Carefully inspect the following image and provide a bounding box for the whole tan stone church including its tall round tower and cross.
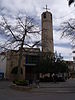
[6,5,54,80]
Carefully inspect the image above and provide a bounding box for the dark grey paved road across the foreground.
[0,80,75,100]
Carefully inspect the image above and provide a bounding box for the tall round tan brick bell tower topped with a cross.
[41,5,54,52]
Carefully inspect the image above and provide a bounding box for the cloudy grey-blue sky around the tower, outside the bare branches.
[0,0,75,60]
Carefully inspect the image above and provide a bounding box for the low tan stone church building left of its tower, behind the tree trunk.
[6,48,40,80]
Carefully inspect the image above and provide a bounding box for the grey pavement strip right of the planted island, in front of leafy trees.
[31,79,75,94]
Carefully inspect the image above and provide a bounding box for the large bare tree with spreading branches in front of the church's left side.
[0,12,40,77]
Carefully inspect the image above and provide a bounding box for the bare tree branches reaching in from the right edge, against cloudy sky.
[60,19,75,43]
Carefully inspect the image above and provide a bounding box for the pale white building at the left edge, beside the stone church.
[0,52,6,78]
